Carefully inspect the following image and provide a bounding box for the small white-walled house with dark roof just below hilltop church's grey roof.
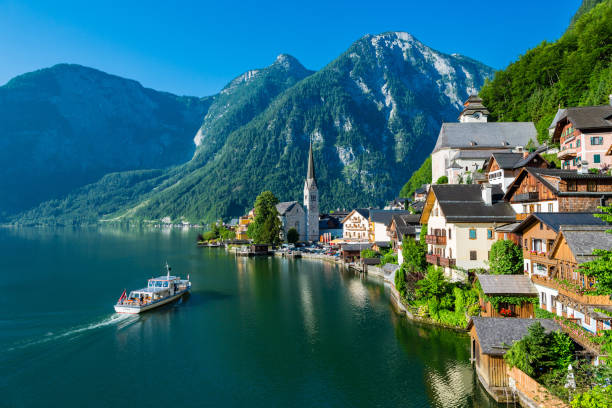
[484,151,550,192]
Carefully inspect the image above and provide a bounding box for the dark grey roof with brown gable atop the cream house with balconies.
[421,184,516,223]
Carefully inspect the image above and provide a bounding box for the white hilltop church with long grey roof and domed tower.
[431,95,537,184]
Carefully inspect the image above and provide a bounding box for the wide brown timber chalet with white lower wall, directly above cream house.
[504,167,612,220]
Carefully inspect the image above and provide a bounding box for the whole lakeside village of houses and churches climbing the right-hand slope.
[218,95,612,406]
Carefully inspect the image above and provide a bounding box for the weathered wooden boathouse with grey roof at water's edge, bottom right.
[468,317,561,403]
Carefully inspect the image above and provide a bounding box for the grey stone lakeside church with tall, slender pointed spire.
[276,142,319,241]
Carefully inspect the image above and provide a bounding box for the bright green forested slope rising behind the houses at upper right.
[480,0,612,141]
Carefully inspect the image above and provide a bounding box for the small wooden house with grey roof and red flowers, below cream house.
[476,274,538,318]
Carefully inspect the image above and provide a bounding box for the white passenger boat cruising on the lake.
[115,263,191,314]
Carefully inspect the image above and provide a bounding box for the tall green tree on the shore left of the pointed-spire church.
[248,191,281,245]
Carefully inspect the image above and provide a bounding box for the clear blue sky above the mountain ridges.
[0,0,581,96]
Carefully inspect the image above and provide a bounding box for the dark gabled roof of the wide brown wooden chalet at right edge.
[504,167,612,200]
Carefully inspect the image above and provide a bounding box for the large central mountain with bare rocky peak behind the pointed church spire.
[11,32,493,222]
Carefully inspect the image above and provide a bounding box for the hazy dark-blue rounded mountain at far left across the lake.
[0,64,212,218]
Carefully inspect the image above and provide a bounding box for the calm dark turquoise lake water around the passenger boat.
[0,228,494,407]
